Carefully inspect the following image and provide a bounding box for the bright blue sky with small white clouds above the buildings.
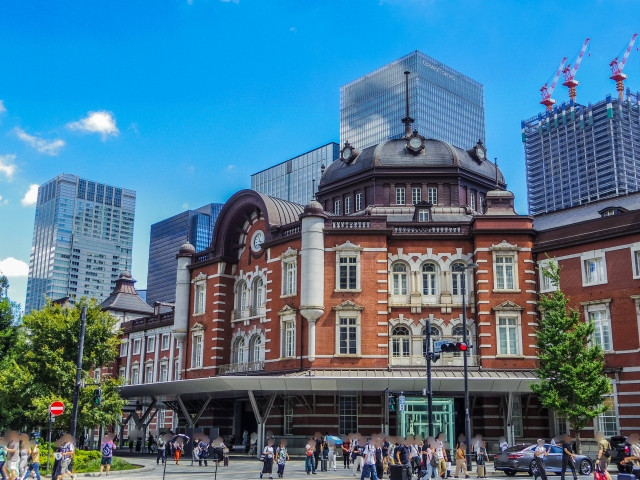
[0,0,640,303]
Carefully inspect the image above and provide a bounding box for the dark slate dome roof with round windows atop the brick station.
[320,138,505,186]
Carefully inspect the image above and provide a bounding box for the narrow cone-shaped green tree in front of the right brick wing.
[531,260,611,452]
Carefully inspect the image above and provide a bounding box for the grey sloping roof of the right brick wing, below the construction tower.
[533,193,640,231]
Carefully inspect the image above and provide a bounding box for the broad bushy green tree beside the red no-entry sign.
[0,298,124,434]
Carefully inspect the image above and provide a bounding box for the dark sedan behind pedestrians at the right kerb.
[493,443,593,477]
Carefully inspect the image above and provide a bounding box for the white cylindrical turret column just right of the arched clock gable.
[300,200,327,362]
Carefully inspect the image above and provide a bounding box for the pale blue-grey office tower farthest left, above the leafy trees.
[25,173,136,313]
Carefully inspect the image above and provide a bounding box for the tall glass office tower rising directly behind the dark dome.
[340,50,485,150]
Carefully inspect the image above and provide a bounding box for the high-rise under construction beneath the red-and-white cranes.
[522,91,640,215]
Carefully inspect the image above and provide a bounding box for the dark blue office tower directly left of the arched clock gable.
[145,203,222,305]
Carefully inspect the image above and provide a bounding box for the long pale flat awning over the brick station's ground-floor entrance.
[121,370,537,404]
